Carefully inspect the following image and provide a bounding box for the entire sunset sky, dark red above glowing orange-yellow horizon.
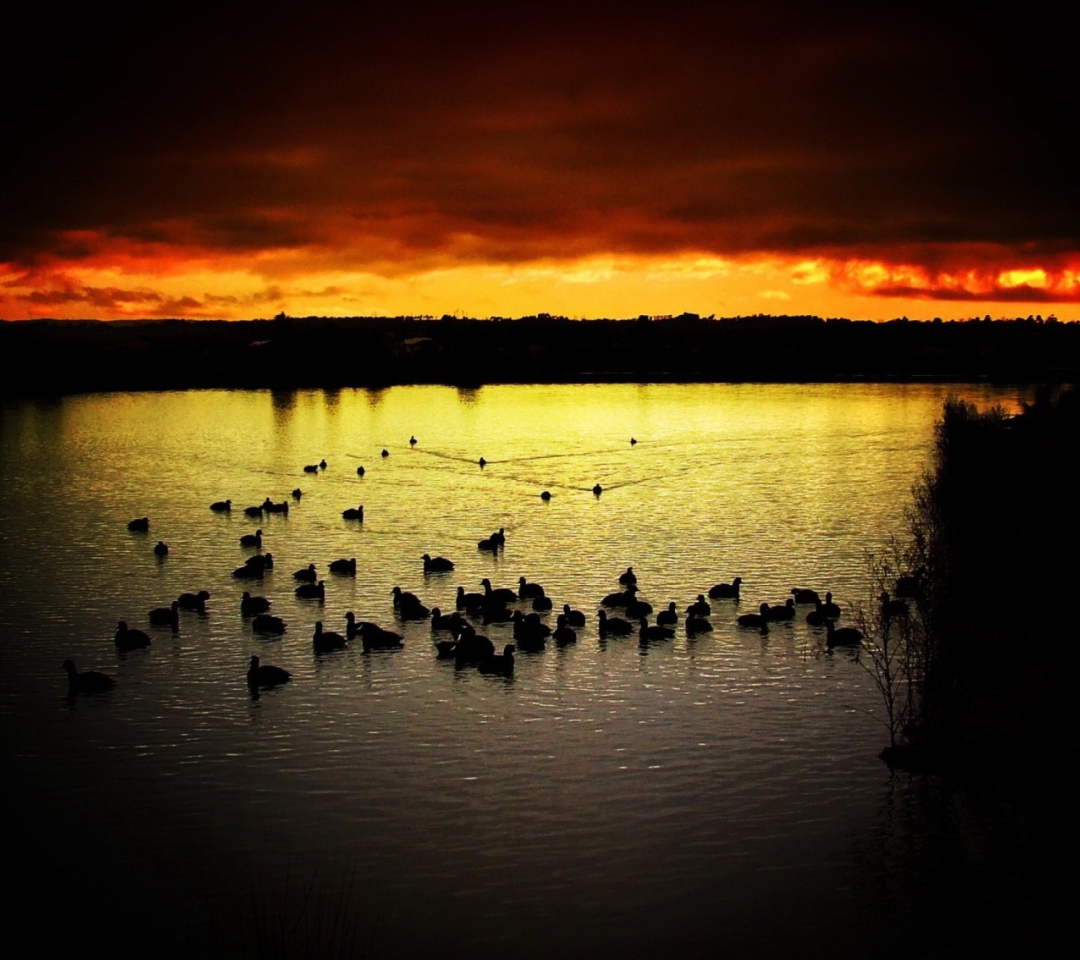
[0,2,1080,319]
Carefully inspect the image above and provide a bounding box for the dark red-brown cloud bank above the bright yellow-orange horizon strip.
[0,3,1080,280]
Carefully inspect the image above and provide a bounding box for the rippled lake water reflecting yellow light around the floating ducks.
[0,384,1018,958]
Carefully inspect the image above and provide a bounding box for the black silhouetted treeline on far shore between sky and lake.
[0,314,1080,396]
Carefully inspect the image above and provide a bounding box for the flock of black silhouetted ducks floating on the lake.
[63,437,919,695]
